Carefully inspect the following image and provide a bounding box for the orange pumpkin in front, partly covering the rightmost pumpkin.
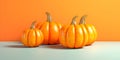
[59,16,85,48]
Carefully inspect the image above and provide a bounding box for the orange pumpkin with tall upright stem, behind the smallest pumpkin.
[36,12,62,44]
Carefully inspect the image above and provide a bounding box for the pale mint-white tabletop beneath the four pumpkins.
[0,42,120,60]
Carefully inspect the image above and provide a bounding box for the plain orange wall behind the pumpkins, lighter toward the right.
[0,0,120,41]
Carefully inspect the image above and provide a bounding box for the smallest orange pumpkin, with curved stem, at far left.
[21,21,44,47]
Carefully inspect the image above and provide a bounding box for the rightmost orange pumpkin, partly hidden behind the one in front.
[79,15,97,46]
